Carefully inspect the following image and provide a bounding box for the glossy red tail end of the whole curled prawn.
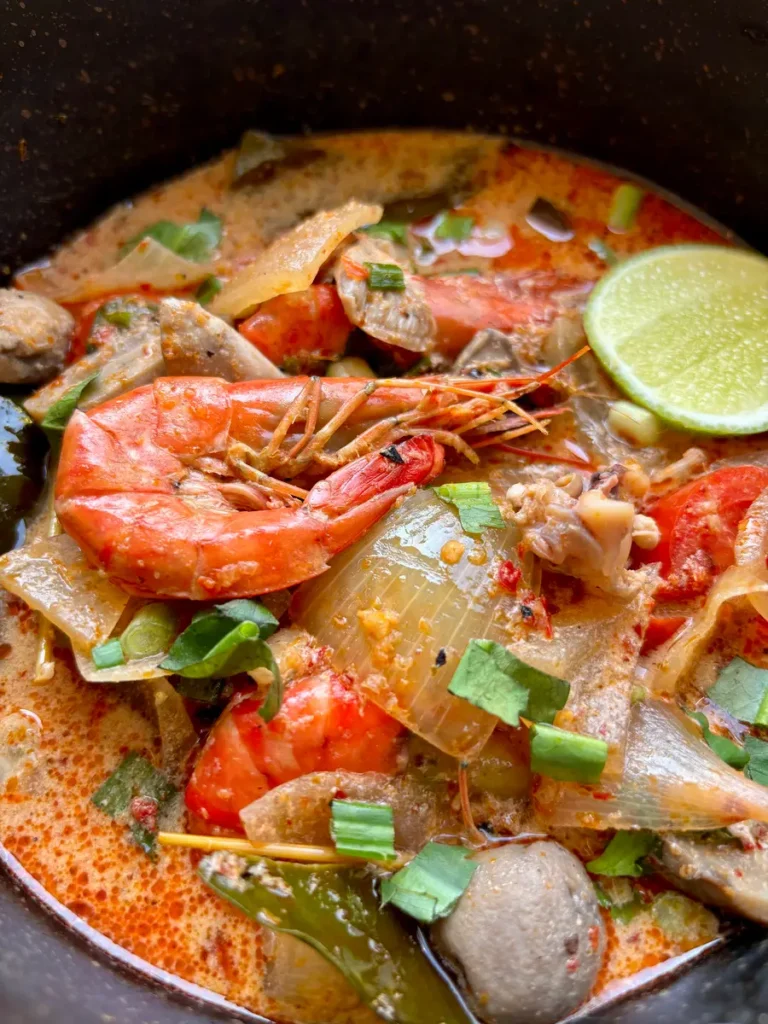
[305,434,444,555]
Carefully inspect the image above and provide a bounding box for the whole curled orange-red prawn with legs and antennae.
[55,377,538,600]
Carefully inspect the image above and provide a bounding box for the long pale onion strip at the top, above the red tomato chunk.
[210,199,384,317]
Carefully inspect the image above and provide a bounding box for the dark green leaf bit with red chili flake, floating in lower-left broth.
[91,751,176,859]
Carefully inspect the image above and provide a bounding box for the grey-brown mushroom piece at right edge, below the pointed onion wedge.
[658,825,768,925]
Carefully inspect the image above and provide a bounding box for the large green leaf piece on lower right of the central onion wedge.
[449,640,570,726]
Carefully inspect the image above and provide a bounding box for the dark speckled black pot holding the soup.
[0,0,768,1024]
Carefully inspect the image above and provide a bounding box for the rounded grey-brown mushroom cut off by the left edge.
[0,288,75,384]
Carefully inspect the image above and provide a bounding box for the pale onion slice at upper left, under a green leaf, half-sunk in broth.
[52,238,211,303]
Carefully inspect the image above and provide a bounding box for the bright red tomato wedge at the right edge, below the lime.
[638,466,768,600]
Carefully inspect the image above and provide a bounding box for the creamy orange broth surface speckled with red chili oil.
[0,132,723,1020]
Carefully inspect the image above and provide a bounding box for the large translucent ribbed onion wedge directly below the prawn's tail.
[292,489,519,758]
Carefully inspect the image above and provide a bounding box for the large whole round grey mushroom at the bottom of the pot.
[432,842,605,1024]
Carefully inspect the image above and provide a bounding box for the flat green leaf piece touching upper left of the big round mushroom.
[381,843,477,925]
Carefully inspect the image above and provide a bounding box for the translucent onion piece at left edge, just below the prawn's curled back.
[0,534,128,650]
